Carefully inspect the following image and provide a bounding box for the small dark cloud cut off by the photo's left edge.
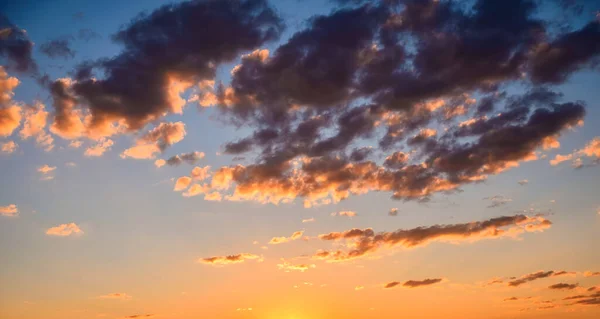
[0,13,37,73]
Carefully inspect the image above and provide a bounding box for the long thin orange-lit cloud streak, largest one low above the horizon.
[313,215,552,262]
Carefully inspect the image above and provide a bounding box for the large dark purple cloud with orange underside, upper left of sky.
[51,0,283,130]
